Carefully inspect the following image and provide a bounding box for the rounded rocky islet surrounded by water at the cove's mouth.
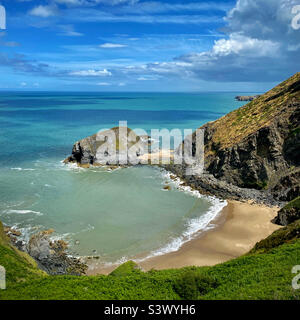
[65,127,151,167]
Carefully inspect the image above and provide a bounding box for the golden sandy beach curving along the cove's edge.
[88,201,280,275]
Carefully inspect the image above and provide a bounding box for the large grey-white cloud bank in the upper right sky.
[123,0,300,82]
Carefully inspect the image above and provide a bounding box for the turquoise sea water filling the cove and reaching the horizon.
[0,92,245,263]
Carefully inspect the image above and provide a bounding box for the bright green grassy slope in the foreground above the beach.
[0,221,300,300]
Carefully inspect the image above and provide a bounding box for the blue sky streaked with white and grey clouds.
[0,0,300,92]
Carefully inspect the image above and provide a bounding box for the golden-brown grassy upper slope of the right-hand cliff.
[205,72,300,149]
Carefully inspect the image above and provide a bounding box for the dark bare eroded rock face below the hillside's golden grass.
[206,103,300,195]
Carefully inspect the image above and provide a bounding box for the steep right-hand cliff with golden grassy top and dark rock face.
[168,73,300,201]
